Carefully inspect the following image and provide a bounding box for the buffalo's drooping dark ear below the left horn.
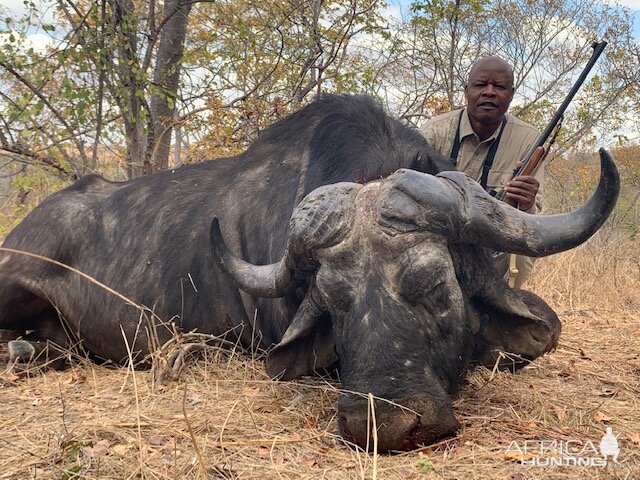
[266,285,338,380]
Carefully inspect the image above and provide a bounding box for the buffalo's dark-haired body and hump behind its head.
[0,95,452,362]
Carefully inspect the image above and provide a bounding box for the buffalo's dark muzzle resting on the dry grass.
[338,395,460,452]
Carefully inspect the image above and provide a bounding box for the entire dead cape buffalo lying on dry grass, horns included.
[0,96,619,450]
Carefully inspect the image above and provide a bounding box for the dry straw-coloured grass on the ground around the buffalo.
[0,241,640,480]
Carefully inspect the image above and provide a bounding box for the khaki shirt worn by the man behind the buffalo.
[420,109,544,288]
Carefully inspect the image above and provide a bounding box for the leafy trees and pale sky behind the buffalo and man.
[0,0,640,215]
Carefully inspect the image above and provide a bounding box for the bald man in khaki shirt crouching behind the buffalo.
[421,57,543,287]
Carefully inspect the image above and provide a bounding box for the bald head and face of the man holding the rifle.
[464,58,514,126]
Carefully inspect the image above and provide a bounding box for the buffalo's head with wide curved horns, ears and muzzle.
[211,151,619,450]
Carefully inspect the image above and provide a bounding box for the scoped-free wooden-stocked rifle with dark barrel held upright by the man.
[496,41,607,200]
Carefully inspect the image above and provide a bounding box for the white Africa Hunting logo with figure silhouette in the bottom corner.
[505,427,620,467]
